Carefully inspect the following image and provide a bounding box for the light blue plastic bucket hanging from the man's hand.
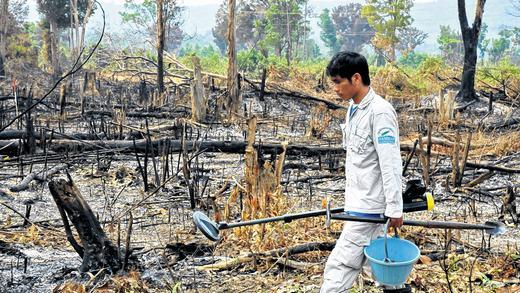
[364,233,421,286]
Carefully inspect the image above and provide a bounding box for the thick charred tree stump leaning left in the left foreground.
[49,176,121,272]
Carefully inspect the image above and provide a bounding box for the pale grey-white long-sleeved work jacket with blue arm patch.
[341,88,403,218]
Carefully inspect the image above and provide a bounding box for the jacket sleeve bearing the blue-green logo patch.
[372,108,403,218]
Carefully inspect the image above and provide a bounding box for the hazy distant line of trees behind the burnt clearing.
[0,0,520,99]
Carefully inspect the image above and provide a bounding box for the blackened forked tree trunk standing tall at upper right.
[458,0,486,101]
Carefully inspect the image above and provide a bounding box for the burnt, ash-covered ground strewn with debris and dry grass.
[0,77,520,292]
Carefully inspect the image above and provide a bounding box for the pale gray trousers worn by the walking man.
[320,221,384,293]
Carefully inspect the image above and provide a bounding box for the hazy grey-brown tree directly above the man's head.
[332,3,375,52]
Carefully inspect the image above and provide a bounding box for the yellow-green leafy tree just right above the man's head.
[361,0,413,61]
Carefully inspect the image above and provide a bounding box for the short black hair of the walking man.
[327,51,370,86]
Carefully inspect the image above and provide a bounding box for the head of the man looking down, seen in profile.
[327,51,370,102]
